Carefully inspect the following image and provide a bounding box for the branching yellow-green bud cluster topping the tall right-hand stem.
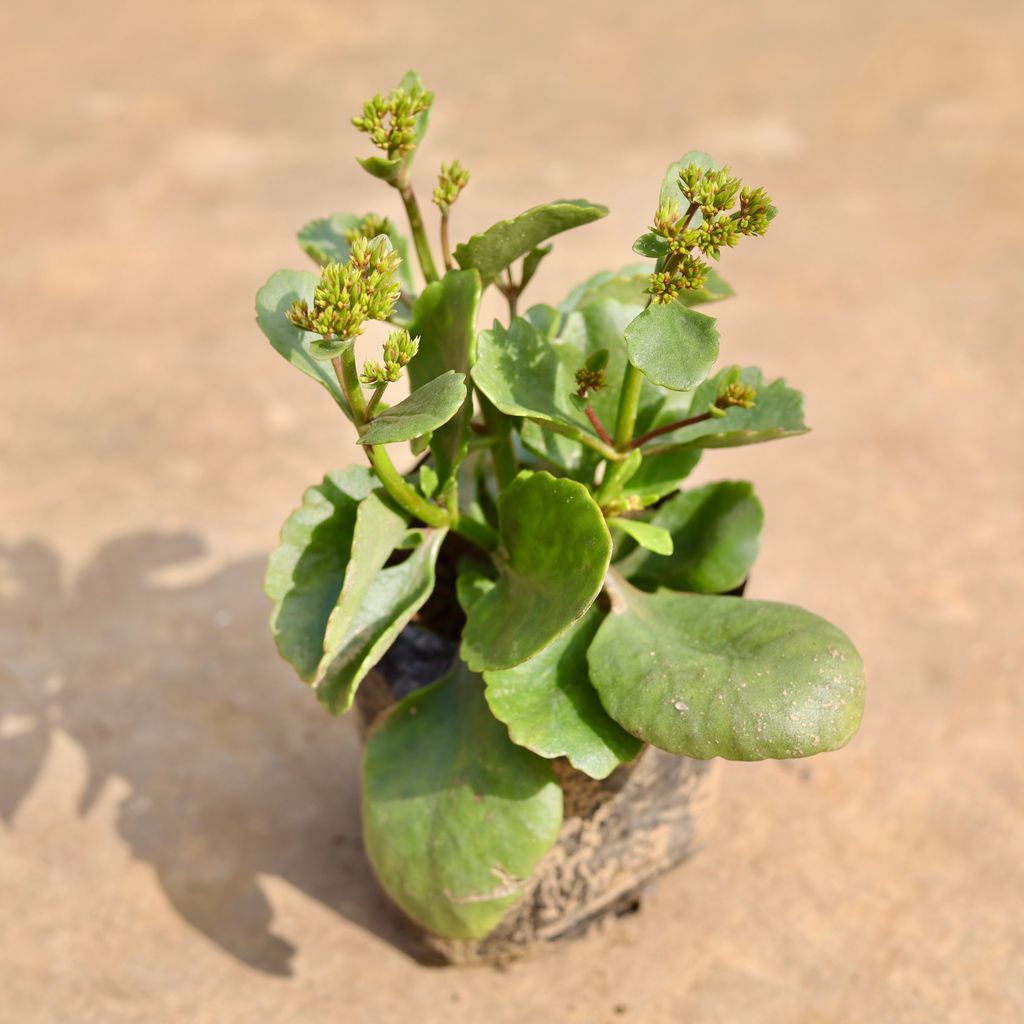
[647,164,775,303]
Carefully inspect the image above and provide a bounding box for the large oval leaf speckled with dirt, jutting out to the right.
[587,585,864,761]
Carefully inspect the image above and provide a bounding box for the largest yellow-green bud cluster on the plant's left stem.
[288,236,401,339]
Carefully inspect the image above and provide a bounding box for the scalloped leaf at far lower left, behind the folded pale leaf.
[264,466,376,681]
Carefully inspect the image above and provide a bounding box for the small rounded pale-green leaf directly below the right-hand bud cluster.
[626,302,718,391]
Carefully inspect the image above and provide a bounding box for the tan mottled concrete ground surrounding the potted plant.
[0,0,1024,1024]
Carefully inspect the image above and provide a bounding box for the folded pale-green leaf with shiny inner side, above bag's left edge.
[315,520,446,715]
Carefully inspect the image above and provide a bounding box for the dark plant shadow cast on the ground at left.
[0,534,417,975]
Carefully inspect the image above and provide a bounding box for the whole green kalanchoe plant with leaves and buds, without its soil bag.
[256,72,863,938]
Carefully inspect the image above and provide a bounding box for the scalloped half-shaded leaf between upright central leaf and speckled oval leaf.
[483,607,642,778]
